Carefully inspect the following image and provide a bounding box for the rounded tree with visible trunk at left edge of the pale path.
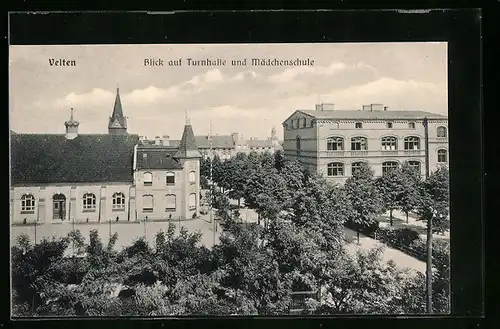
[344,164,382,243]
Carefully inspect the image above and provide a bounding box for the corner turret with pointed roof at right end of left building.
[174,115,201,219]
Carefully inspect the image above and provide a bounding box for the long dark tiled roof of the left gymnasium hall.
[11,134,139,185]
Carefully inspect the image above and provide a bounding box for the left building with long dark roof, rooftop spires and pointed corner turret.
[10,90,201,223]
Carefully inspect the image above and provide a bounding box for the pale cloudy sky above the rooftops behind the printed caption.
[9,43,448,139]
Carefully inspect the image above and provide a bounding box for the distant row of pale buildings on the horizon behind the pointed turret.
[140,128,282,160]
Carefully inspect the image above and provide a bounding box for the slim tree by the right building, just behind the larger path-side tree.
[376,168,403,226]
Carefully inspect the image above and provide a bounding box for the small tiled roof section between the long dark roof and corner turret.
[137,145,182,169]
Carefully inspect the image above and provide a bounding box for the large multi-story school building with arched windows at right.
[283,103,448,183]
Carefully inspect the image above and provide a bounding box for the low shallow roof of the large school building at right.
[299,110,447,120]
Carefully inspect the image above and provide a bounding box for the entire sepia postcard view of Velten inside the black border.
[9,42,453,318]
